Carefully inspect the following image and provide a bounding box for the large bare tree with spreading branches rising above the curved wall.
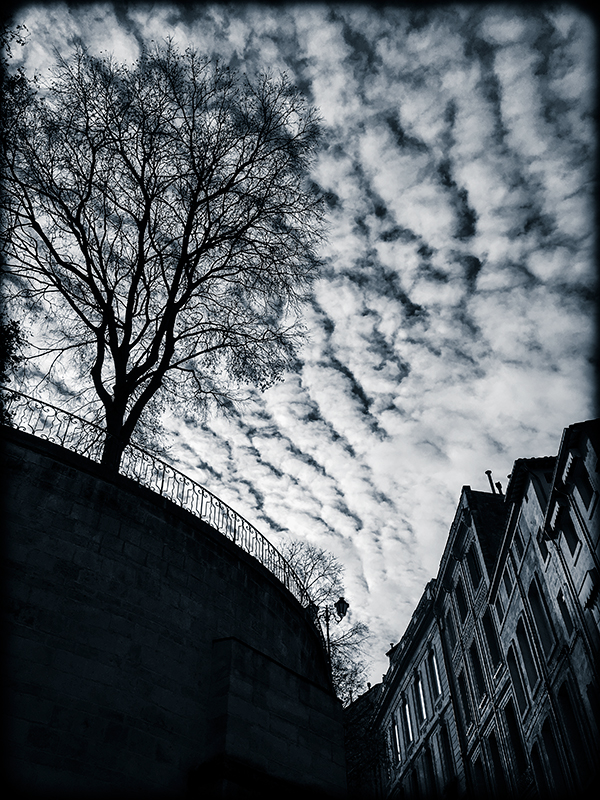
[1,42,323,470]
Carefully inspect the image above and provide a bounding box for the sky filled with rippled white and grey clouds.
[7,2,596,681]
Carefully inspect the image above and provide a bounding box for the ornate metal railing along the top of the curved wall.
[0,387,311,607]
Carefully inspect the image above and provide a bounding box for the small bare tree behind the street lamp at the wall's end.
[279,539,370,705]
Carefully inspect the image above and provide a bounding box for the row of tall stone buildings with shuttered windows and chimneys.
[370,420,600,798]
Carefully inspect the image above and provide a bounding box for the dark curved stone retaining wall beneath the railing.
[3,431,345,797]
